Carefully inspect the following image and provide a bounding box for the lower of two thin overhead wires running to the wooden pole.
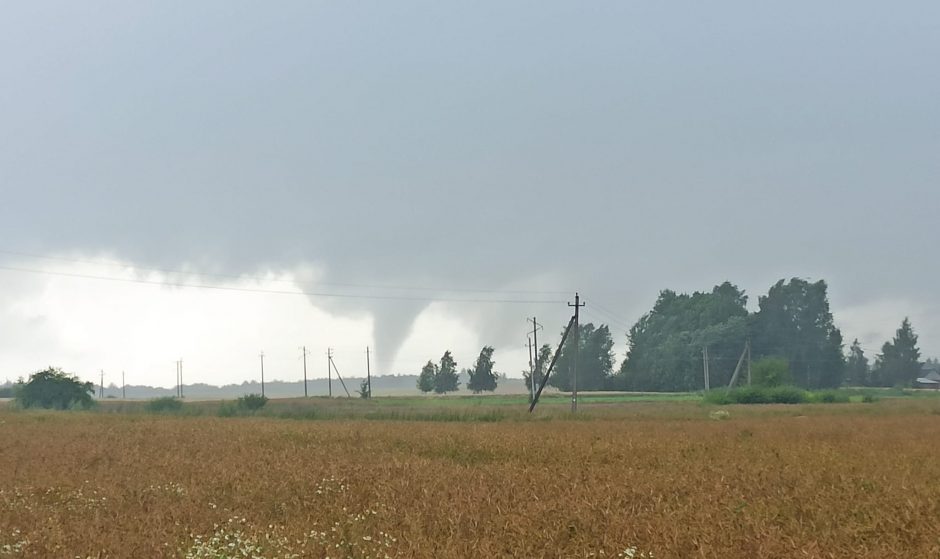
[0,266,562,305]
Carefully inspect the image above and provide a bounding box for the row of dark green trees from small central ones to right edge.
[418,278,924,393]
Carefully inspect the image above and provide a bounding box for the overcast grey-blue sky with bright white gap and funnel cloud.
[0,1,940,384]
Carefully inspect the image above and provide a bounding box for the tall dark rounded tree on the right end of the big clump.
[751,278,845,388]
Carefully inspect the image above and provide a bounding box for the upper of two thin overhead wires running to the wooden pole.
[0,249,568,295]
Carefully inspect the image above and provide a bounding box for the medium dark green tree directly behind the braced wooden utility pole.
[548,322,614,392]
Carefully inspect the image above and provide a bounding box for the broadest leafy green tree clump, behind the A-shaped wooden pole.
[619,282,747,391]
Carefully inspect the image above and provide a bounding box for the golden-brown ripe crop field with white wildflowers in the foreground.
[0,401,940,559]
